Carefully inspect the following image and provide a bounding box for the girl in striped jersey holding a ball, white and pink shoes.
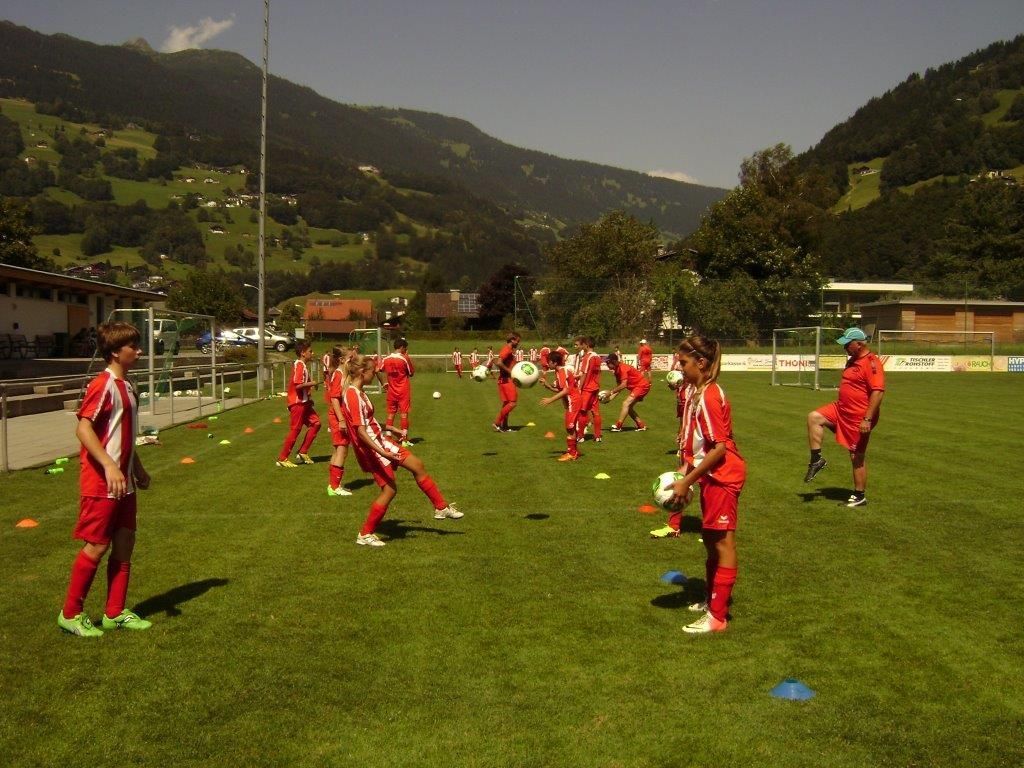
[672,336,746,634]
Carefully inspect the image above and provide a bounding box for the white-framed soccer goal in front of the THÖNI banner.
[771,326,846,389]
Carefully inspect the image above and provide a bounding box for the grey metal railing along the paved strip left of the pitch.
[0,361,292,472]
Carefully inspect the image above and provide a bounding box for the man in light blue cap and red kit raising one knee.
[804,327,886,507]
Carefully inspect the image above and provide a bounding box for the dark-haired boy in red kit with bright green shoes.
[57,323,153,637]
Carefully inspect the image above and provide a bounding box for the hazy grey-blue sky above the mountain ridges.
[0,0,1024,186]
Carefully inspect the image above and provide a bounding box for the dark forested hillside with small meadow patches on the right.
[797,35,1024,299]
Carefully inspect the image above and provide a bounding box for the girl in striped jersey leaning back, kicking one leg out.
[342,356,463,547]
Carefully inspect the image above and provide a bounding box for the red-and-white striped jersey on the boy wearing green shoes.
[77,369,138,499]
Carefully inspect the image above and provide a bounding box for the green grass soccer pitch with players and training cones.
[0,374,1024,767]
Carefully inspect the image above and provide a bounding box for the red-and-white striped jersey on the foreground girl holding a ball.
[683,382,746,489]
